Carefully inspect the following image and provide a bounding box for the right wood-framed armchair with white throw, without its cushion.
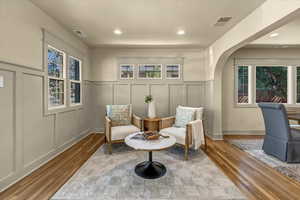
[160,106,207,160]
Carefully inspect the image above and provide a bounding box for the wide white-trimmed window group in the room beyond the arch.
[235,63,300,105]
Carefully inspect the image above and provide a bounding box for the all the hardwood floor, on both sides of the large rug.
[0,134,300,200]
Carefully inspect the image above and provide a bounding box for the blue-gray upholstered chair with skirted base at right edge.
[258,103,300,163]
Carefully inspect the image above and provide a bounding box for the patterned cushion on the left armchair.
[106,105,131,126]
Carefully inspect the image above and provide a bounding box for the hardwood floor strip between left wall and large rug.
[0,134,105,200]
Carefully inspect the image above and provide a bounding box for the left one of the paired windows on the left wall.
[47,46,66,109]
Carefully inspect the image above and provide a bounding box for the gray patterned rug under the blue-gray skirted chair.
[228,139,300,182]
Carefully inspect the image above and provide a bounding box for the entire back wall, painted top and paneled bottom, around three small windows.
[91,48,213,134]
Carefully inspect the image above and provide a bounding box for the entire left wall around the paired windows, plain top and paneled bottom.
[0,0,92,191]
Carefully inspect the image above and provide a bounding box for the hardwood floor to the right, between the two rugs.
[207,136,300,200]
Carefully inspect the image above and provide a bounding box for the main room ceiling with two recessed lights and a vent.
[31,0,265,47]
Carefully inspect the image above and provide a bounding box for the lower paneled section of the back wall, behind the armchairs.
[92,81,210,134]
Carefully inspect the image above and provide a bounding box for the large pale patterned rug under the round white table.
[52,144,246,200]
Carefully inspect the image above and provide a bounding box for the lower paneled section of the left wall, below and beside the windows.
[0,62,93,191]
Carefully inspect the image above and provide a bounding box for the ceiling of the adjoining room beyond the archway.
[250,16,300,47]
